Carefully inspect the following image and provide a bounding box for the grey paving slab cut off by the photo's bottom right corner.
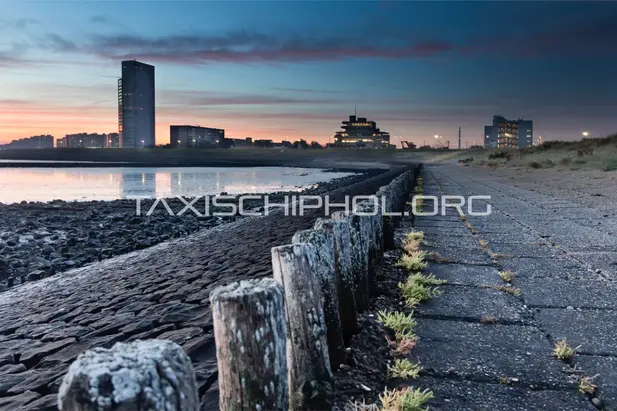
[575,355,617,410]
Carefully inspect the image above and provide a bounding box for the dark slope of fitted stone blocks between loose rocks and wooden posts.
[0,171,399,411]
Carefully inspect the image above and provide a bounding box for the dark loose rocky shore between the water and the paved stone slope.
[0,170,383,291]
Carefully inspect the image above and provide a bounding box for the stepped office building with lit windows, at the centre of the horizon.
[334,114,390,148]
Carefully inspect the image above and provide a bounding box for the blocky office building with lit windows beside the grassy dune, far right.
[484,116,533,149]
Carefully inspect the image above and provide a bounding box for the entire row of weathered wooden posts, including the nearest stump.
[58,168,419,411]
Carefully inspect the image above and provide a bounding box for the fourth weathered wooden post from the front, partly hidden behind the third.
[291,229,346,370]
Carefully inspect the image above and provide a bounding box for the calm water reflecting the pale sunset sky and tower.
[0,167,352,203]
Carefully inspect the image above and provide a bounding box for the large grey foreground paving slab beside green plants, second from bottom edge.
[411,318,570,387]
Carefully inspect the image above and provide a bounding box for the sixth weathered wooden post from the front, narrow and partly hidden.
[332,211,369,312]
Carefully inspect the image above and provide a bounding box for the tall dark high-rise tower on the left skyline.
[118,60,156,148]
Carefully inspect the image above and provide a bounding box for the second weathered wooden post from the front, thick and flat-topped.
[210,278,289,411]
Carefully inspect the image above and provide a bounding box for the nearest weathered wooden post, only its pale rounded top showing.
[58,340,200,411]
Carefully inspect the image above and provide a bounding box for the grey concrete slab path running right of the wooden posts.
[404,165,617,411]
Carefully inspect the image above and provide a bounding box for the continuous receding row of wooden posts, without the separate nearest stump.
[210,169,418,411]
